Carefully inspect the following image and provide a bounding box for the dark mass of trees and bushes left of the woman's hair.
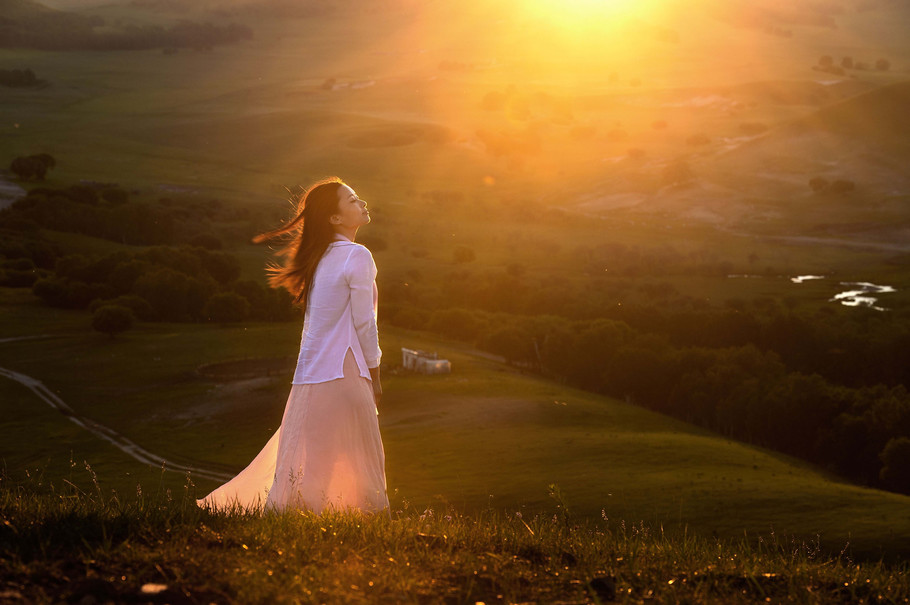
[0,184,296,333]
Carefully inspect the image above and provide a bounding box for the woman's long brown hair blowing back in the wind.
[253,176,344,313]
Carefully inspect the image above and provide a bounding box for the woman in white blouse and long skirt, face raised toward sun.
[198,177,389,513]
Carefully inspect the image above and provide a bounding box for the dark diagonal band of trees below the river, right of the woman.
[380,304,910,493]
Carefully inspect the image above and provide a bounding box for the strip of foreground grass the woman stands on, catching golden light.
[0,477,910,604]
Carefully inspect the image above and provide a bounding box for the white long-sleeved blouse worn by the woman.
[292,234,382,384]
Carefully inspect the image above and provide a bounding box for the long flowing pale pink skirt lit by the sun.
[197,349,389,514]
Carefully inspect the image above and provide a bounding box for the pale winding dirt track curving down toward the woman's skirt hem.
[0,368,231,482]
